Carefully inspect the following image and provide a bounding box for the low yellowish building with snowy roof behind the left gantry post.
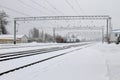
[0,34,28,44]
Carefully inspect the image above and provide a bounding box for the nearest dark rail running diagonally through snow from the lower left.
[0,43,90,76]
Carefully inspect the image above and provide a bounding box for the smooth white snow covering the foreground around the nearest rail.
[0,43,120,80]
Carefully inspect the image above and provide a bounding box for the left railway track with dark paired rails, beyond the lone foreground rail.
[0,43,88,62]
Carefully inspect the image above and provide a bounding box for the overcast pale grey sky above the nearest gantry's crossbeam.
[0,0,120,29]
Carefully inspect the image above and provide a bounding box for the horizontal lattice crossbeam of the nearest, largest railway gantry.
[14,15,111,21]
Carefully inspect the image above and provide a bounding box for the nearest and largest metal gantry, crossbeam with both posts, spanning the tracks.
[14,15,111,44]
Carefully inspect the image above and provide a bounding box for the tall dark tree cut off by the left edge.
[0,11,8,34]
